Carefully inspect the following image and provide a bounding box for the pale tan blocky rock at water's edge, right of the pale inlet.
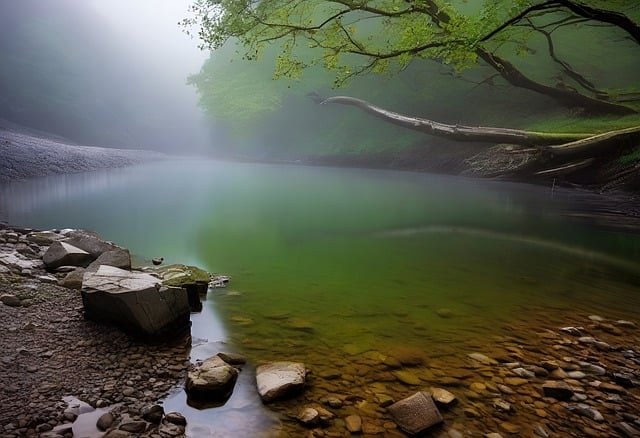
[256,362,306,403]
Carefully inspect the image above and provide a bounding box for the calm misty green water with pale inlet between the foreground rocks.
[0,161,640,436]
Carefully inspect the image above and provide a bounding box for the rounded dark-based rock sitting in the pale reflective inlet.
[185,356,238,402]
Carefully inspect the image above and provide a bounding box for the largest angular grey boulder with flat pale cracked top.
[81,265,190,339]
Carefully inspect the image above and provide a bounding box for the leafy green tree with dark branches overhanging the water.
[184,0,640,186]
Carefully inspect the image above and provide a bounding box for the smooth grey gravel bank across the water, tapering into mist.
[0,128,167,183]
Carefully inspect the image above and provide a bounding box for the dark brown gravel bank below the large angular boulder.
[0,228,191,437]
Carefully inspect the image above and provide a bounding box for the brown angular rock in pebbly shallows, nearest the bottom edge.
[387,392,443,435]
